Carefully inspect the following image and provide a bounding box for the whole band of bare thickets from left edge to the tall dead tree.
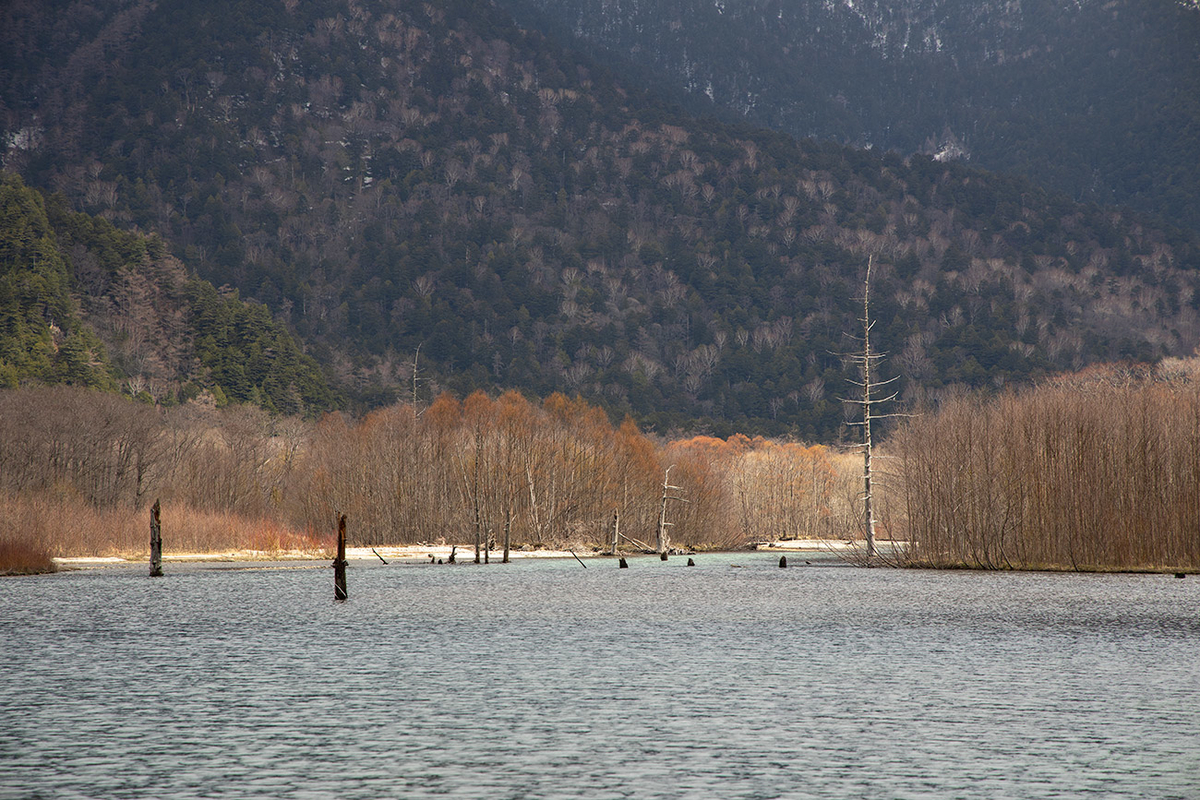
[0,387,853,555]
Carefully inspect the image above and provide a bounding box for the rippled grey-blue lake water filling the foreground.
[0,554,1200,800]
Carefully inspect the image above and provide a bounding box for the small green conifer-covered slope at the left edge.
[0,174,336,414]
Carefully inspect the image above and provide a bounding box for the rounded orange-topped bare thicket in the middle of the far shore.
[304,392,676,554]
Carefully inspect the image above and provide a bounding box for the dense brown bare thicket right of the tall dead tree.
[892,369,1200,569]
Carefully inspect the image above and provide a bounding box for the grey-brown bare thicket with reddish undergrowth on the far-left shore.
[0,386,322,555]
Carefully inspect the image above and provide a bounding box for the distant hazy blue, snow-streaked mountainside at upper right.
[503,0,1200,235]
